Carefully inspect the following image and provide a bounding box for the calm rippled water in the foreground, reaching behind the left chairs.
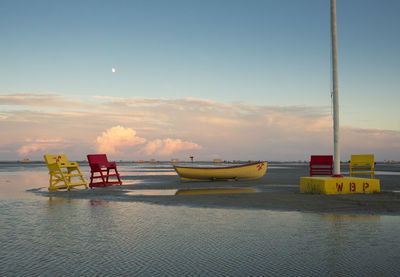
[0,162,400,276]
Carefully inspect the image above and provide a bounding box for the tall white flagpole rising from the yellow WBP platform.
[331,0,340,175]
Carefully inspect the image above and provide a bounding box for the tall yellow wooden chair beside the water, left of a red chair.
[44,155,87,191]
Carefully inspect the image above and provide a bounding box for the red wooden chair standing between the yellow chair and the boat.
[87,154,122,188]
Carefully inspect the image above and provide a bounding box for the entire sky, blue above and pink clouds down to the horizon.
[0,0,400,161]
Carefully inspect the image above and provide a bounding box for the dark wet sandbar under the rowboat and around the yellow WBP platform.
[33,165,400,215]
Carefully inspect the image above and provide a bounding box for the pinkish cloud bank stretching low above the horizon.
[0,94,400,160]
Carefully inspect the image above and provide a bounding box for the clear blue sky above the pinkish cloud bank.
[0,0,400,160]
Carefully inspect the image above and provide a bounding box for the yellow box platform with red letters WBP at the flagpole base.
[300,176,380,194]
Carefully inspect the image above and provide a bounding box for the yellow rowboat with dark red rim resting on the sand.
[174,162,267,180]
